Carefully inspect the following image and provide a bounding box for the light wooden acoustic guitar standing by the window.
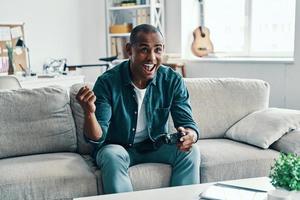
[192,0,214,57]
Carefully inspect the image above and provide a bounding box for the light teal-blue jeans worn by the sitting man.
[96,144,200,194]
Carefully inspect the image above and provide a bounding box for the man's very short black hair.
[129,24,164,45]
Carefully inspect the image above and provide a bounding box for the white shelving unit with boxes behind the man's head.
[105,0,165,59]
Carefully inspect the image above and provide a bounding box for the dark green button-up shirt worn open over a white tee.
[93,61,199,147]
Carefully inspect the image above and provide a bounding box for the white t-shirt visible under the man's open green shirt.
[132,83,148,143]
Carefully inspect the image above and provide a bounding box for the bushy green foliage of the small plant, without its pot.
[269,153,300,191]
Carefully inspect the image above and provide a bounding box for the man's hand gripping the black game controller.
[177,127,197,151]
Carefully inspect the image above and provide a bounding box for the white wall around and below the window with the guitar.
[166,0,300,109]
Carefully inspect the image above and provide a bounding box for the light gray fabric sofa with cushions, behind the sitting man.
[0,79,300,200]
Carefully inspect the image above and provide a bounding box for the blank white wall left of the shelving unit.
[0,0,106,79]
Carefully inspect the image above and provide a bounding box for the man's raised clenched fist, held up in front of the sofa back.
[76,86,96,114]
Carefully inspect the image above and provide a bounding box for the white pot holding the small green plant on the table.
[268,188,300,200]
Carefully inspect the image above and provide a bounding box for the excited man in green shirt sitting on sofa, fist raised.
[77,24,200,194]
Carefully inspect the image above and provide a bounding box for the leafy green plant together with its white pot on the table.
[268,153,300,199]
